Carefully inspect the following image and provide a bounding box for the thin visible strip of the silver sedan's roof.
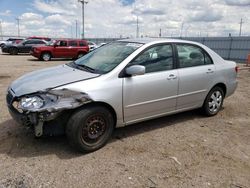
[118,38,199,44]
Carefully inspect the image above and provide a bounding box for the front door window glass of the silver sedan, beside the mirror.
[131,44,173,73]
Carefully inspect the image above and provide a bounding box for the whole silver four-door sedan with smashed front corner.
[6,38,238,152]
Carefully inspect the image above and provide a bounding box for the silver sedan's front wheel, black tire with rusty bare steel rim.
[66,106,114,153]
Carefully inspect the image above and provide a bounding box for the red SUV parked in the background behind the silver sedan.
[30,39,89,61]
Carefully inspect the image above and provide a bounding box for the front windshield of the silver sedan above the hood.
[74,42,142,74]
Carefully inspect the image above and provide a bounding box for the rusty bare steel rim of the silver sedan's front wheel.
[81,114,107,145]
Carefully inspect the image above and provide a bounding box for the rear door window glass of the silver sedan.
[176,44,213,68]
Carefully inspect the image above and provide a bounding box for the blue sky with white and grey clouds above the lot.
[0,0,250,37]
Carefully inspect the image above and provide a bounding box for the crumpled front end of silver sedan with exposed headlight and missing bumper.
[6,89,92,137]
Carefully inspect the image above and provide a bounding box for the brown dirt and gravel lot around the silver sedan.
[0,50,250,188]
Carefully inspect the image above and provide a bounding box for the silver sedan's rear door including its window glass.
[176,44,215,110]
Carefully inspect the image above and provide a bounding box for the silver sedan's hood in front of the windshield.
[10,65,99,97]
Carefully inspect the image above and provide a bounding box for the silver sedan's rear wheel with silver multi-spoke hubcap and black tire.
[202,86,225,116]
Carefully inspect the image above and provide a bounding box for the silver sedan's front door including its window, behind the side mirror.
[123,44,178,124]
